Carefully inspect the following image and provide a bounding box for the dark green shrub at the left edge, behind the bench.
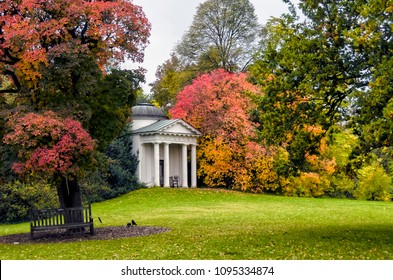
[0,181,58,223]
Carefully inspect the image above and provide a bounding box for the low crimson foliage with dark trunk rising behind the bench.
[3,111,94,207]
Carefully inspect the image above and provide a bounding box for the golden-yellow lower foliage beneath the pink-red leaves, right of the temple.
[198,136,278,192]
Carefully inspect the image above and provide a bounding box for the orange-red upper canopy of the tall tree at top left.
[0,0,150,91]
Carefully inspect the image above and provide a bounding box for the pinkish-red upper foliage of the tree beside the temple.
[170,69,259,141]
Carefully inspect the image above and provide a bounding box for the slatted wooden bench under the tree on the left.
[30,205,94,239]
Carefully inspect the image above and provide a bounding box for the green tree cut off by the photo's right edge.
[350,1,393,157]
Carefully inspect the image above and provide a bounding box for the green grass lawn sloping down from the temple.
[0,188,393,260]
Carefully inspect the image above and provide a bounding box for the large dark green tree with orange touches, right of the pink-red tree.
[251,0,370,173]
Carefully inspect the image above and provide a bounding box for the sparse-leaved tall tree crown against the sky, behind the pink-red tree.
[176,0,259,71]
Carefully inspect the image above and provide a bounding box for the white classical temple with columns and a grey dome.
[132,103,201,188]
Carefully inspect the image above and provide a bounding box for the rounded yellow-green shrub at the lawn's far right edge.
[354,161,392,201]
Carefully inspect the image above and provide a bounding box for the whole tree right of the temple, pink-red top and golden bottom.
[170,69,276,190]
